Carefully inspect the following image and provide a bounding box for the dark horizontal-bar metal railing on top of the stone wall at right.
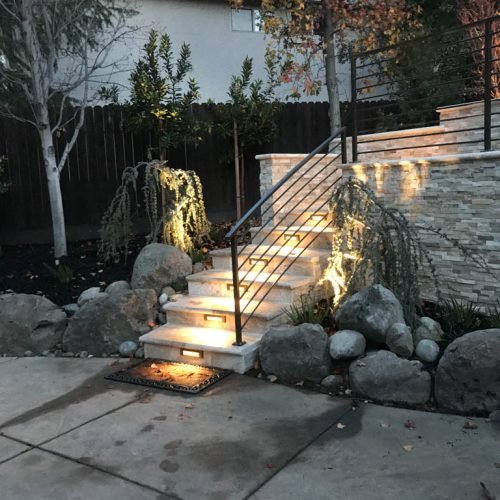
[351,16,500,161]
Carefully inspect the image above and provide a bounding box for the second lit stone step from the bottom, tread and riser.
[162,296,286,332]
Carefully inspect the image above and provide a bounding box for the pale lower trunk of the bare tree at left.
[39,125,68,259]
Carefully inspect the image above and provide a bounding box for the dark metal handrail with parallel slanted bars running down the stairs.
[225,127,347,345]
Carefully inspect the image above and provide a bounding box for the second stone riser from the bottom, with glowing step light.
[167,310,286,333]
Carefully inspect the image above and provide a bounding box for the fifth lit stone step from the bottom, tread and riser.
[250,224,333,250]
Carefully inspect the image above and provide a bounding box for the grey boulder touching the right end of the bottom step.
[259,323,331,382]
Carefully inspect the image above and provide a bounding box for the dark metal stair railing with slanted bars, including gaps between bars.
[226,128,347,346]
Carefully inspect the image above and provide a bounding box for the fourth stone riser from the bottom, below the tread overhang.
[212,254,327,280]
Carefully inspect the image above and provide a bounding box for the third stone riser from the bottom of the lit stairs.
[188,279,314,305]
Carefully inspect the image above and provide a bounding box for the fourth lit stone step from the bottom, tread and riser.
[210,245,330,280]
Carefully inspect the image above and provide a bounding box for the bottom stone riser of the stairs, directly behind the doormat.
[144,342,258,373]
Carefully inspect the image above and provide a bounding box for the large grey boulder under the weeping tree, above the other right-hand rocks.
[335,285,405,343]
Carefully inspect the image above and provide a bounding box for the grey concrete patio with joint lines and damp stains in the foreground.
[0,358,500,500]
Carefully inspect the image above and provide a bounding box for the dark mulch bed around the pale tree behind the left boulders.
[0,238,144,306]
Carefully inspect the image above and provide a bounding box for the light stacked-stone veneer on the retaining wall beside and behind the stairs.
[257,151,500,306]
